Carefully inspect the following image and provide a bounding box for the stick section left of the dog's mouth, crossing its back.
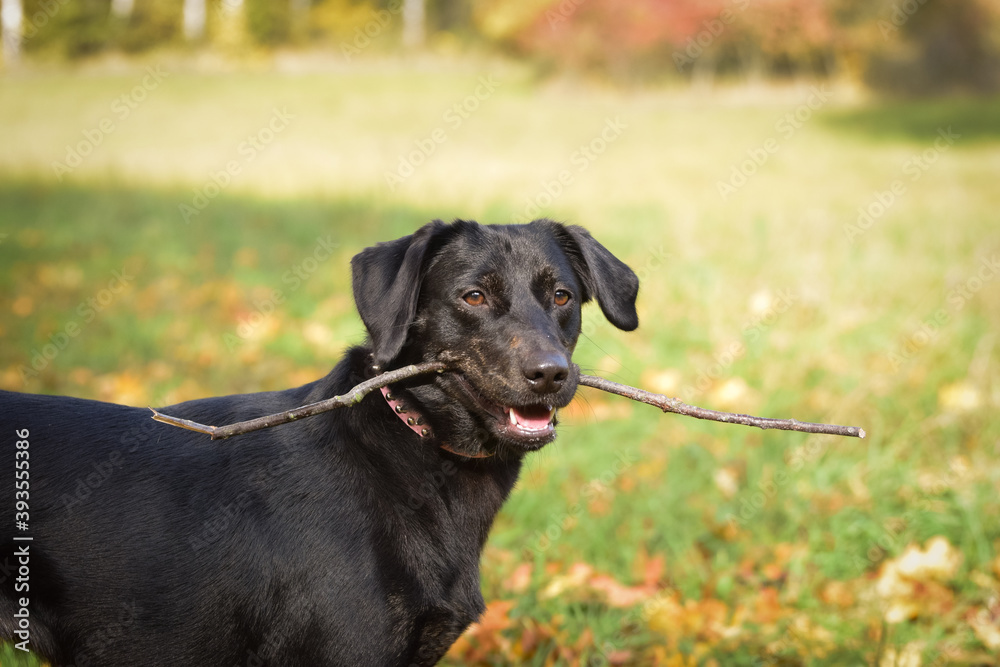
[150,361,446,440]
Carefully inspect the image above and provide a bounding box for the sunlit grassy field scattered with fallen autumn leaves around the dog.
[0,61,1000,667]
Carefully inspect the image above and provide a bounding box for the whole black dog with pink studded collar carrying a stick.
[0,220,638,667]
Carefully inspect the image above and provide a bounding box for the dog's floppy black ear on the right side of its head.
[546,221,639,331]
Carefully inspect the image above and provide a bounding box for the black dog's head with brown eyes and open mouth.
[351,220,639,456]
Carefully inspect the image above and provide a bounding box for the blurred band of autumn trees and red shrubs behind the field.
[7,0,1000,94]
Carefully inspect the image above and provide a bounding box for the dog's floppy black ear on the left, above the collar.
[351,220,448,366]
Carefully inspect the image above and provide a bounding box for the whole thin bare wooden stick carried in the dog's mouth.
[150,361,865,440]
